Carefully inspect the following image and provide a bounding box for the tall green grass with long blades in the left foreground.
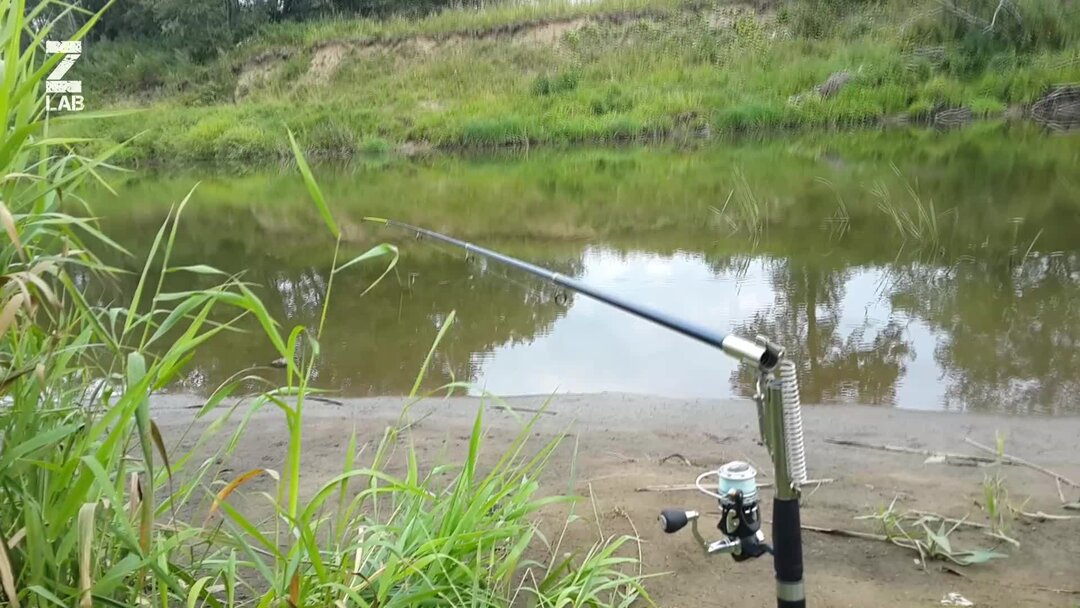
[0,0,644,608]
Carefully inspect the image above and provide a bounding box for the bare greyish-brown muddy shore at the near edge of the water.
[154,394,1080,608]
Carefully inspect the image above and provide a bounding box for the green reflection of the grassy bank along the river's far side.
[89,123,1080,253]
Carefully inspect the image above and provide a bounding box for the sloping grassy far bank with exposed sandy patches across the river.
[76,0,1080,162]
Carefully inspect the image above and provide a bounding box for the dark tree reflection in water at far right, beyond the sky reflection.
[891,253,1080,414]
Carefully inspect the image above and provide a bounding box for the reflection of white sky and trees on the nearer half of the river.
[95,240,1080,413]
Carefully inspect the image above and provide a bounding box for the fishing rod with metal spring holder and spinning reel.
[363,217,807,608]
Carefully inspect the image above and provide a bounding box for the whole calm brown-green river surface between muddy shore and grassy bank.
[91,127,1080,414]
